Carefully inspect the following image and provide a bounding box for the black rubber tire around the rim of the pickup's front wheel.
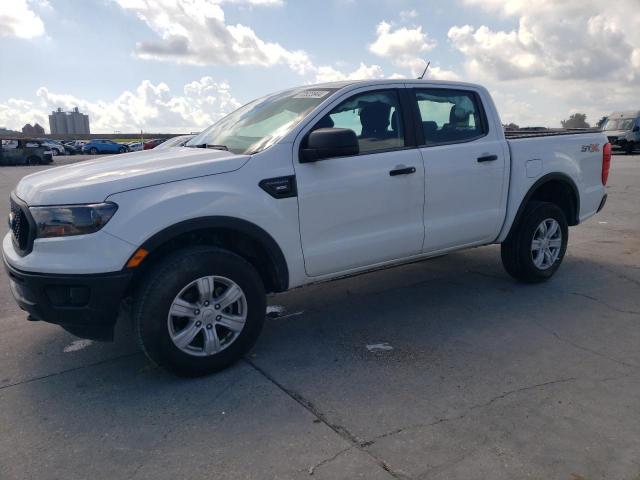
[132,247,266,377]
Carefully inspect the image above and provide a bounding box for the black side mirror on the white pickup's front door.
[300,128,360,163]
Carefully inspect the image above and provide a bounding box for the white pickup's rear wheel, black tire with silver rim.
[501,202,569,283]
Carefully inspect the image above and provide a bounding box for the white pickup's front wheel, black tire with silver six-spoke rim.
[133,247,266,377]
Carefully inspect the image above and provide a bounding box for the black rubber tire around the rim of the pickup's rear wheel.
[501,202,569,283]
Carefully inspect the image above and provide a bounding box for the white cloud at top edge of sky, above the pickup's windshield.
[116,0,312,74]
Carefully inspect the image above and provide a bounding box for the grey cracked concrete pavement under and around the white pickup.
[0,155,640,480]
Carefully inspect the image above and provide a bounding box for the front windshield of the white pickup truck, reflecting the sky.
[185,88,336,154]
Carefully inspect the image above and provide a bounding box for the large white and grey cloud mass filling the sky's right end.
[448,0,640,126]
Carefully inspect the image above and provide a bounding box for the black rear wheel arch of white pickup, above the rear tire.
[509,173,580,239]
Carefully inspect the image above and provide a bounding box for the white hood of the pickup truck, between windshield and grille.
[15,147,250,205]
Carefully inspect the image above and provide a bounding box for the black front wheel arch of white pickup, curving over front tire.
[125,216,289,292]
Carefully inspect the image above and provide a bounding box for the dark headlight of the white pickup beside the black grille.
[29,202,118,238]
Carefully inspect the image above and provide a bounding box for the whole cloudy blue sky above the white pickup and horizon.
[0,0,640,133]
